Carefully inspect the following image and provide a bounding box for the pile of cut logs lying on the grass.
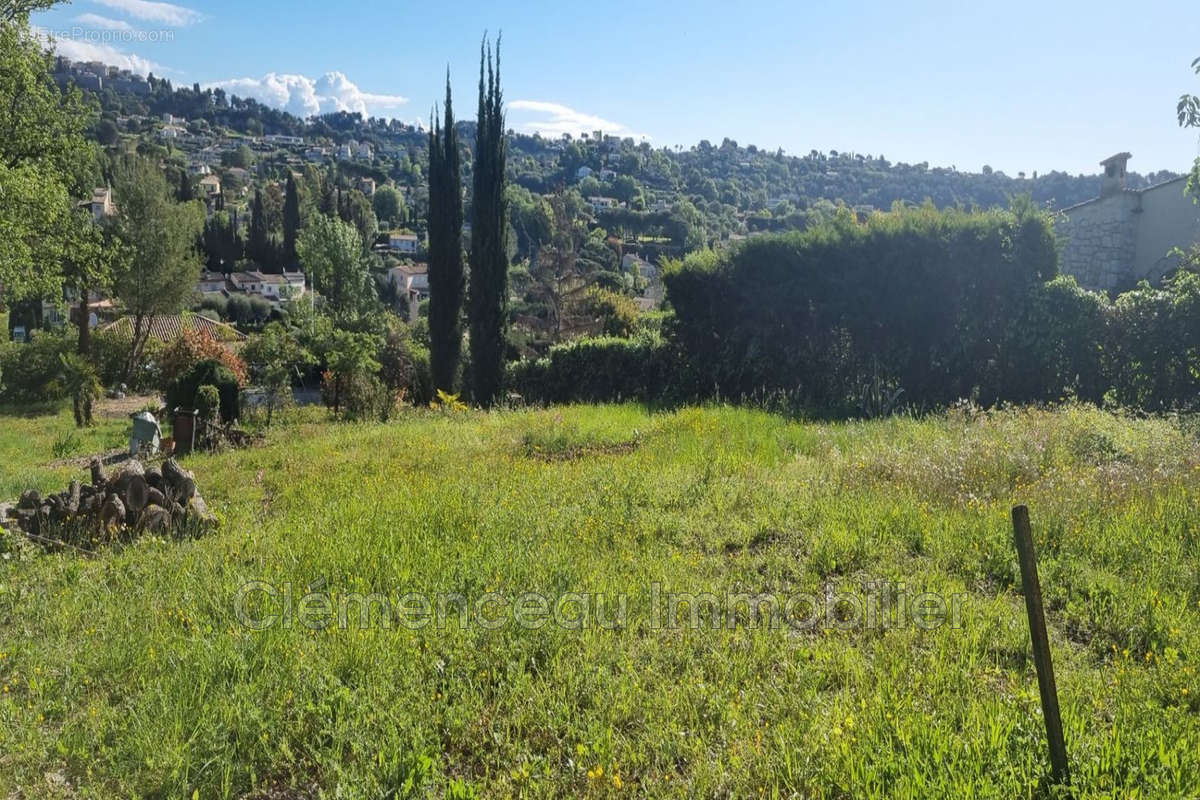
[8,458,216,545]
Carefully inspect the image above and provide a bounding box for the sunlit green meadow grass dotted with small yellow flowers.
[0,407,1200,798]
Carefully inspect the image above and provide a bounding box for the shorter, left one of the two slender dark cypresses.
[428,70,467,392]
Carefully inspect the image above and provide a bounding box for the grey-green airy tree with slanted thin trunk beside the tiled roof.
[113,156,204,381]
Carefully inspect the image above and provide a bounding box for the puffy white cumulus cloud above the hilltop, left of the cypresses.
[208,72,408,116]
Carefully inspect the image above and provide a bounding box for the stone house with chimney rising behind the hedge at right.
[1057,152,1200,291]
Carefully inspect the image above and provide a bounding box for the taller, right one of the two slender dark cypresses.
[467,38,509,408]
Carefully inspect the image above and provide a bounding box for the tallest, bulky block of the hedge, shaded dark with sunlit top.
[665,201,1057,414]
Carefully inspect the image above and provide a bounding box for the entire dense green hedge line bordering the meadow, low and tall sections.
[520,204,1200,416]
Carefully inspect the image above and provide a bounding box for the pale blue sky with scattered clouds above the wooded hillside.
[25,0,1200,175]
